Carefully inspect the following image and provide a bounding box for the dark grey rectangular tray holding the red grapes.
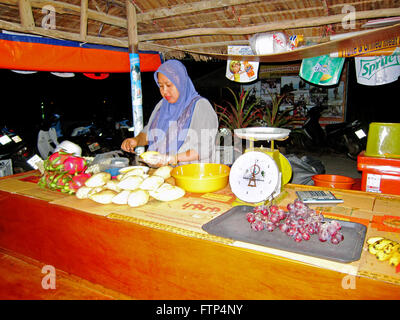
[202,206,367,263]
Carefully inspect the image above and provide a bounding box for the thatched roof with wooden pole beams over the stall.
[0,0,400,61]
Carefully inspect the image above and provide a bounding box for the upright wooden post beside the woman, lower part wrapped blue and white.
[126,0,144,154]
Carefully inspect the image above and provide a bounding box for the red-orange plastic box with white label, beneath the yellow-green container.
[357,152,400,194]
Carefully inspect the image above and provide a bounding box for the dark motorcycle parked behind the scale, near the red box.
[287,104,368,160]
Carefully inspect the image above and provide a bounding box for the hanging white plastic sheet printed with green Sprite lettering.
[354,48,400,86]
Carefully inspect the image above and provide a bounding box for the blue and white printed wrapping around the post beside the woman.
[129,53,144,154]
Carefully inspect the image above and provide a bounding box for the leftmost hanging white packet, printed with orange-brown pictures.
[226,46,258,83]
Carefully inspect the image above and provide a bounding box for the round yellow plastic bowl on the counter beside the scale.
[171,163,231,193]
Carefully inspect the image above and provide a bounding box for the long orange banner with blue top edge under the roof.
[0,33,161,73]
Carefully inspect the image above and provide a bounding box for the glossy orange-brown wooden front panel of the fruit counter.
[0,171,400,300]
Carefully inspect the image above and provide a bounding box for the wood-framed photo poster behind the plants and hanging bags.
[245,64,347,126]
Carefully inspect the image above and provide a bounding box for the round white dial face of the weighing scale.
[229,151,280,203]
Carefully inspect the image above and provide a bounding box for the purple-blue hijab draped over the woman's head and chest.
[148,60,200,153]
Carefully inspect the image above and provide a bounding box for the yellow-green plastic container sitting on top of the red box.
[365,122,400,158]
